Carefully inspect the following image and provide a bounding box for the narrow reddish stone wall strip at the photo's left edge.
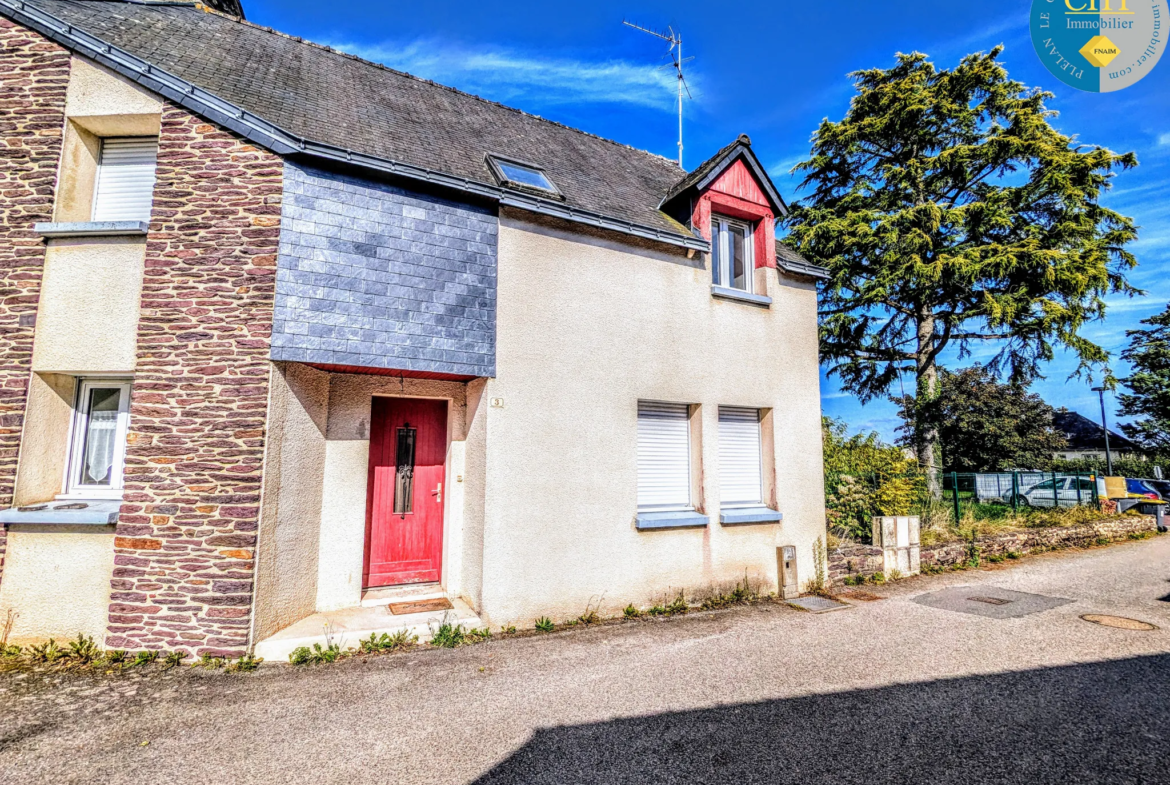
[0,19,69,589]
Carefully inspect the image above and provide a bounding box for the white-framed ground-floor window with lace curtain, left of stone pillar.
[64,379,130,498]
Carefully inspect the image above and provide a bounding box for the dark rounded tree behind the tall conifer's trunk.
[900,367,1067,471]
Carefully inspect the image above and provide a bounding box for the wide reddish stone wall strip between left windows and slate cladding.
[105,104,282,656]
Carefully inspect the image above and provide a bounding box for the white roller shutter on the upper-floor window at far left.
[94,137,158,221]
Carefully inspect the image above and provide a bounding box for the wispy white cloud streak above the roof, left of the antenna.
[320,39,683,111]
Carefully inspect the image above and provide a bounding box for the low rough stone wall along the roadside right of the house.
[828,516,1157,585]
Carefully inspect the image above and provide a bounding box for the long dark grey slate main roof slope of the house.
[0,0,833,269]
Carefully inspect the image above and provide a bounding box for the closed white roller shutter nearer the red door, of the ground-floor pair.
[638,401,690,510]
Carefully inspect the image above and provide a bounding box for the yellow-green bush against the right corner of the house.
[823,416,925,540]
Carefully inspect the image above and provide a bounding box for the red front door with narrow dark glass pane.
[362,398,447,587]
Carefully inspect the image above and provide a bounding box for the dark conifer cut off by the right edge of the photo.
[1117,305,1170,457]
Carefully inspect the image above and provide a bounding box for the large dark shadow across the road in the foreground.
[476,655,1170,785]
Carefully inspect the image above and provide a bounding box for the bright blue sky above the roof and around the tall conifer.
[245,0,1170,438]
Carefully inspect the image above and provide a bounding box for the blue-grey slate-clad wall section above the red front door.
[271,161,497,377]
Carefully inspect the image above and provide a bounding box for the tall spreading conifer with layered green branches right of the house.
[787,47,1137,489]
